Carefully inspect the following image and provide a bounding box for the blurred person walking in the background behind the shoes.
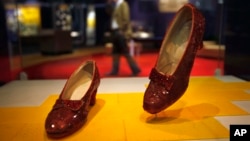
[106,0,141,76]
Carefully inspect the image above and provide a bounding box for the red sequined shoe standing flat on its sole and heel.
[45,61,100,138]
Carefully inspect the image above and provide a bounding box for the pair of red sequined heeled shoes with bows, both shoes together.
[45,4,205,138]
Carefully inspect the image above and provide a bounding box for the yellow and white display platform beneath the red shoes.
[0,76,250,141]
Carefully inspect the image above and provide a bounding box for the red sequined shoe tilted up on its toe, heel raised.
[143,4,205,114]
